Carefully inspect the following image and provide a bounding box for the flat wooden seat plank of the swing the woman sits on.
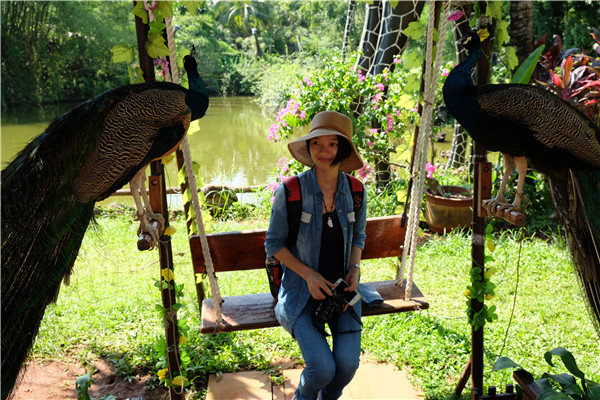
[200,281,429,333]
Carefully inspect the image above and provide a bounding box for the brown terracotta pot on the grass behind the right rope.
[424,186,473,233]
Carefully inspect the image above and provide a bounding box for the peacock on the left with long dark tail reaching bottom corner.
[1,56,209,399]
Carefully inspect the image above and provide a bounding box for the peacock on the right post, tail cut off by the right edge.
[443,33,600,335]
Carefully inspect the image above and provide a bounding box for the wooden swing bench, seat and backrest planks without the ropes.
[190,215,429,333]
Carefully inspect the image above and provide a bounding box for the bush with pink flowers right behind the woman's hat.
[269,50,420,187]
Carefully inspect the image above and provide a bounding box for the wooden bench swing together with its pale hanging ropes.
[184,3,450,334]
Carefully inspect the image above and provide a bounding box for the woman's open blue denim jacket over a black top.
[265,167,367,333]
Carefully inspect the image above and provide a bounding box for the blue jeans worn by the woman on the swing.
[294,298,361,400]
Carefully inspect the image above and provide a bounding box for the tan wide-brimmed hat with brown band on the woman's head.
[288,111,363,172]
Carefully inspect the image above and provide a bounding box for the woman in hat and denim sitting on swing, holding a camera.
[265,111,366,400]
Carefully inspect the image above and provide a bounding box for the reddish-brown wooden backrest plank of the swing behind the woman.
[190,215,406,274]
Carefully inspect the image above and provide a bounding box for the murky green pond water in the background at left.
[0,97,288,203]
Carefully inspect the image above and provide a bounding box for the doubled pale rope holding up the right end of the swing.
[400,1,450,301]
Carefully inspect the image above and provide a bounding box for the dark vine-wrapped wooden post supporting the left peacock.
[134,1,185,400]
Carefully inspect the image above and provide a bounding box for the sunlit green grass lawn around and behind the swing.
[32,211,600,399]
